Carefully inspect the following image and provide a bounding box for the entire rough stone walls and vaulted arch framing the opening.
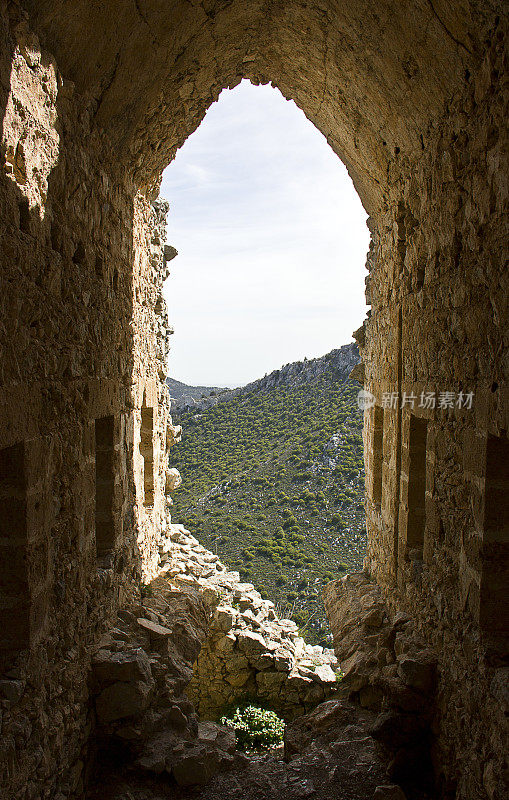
[0,0,509,800]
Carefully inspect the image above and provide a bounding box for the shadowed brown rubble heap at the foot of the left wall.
[91,578,250,786]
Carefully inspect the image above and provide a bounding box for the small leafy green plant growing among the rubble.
[220,705,285,751]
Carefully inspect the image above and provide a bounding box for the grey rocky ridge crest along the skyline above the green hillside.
[166,342,359,411]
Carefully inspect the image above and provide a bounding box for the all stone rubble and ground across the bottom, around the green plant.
[88,525,435,800]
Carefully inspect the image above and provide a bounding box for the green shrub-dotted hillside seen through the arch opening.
[172,345,366,643]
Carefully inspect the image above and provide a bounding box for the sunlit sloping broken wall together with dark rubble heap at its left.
[90,525,342,786]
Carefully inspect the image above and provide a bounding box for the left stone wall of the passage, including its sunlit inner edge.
[0,5,179,800]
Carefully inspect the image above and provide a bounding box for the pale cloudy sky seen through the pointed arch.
[161,81,369,386]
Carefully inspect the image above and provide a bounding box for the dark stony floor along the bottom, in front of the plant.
[88,699,430,800]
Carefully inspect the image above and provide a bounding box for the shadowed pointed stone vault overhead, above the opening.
[22,0,488,215]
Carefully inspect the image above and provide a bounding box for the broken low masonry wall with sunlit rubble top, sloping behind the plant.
[159,525,337,719]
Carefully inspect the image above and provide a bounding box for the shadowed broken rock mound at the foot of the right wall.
[324,572,441,797]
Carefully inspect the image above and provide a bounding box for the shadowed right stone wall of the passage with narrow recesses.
[356,18,509,798]
